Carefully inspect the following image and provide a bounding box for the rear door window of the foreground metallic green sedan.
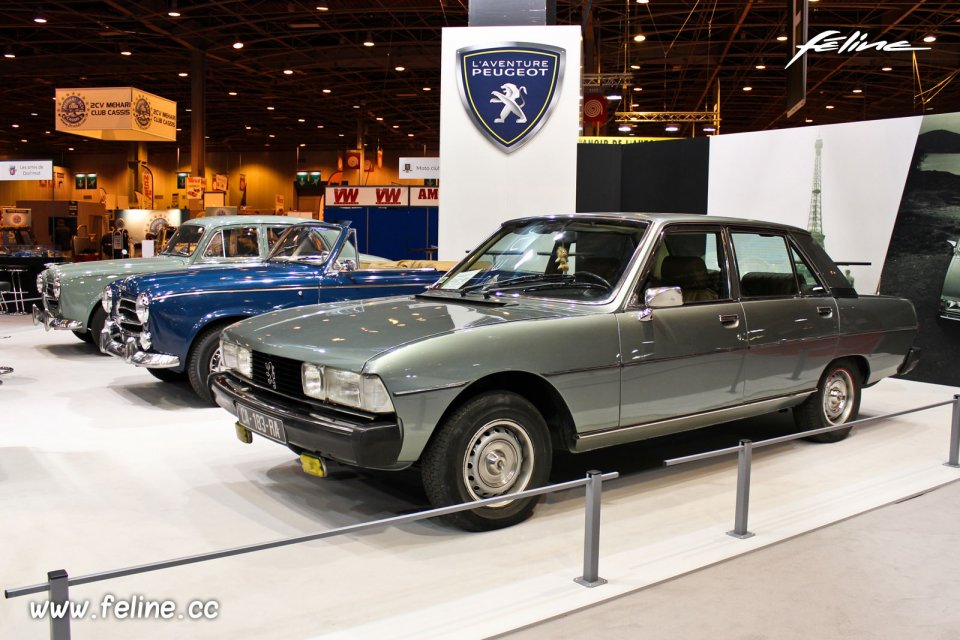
[731,232,798,298]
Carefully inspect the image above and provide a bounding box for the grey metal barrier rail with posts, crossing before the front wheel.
[3,471,620,640]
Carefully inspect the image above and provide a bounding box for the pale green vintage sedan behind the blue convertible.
[33,216,302,344]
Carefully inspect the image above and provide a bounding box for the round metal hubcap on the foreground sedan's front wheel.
[463,420,534,506]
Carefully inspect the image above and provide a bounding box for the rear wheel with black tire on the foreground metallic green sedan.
[793,360,863,442]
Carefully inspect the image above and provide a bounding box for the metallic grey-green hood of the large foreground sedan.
[224,296,572,371]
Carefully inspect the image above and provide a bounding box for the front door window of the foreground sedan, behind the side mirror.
[641,229,730,303]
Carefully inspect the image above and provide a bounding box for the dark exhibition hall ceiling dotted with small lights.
[0,0,960,159]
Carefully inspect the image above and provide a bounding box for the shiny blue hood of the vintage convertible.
[121,262,318,298]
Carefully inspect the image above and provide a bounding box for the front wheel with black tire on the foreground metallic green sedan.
[421,391,552,531]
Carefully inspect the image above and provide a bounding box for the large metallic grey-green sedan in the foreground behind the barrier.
[212,213,918,530]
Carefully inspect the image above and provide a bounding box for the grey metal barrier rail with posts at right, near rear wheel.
[663,395,960,538]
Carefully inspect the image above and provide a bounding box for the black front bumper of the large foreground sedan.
[210,372,403,469]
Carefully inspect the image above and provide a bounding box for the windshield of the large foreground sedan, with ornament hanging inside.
[434,218,647,301]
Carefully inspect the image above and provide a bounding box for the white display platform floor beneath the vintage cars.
[0,316,960,640]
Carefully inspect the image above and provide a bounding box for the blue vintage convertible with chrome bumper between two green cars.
[100,222,454,402]
